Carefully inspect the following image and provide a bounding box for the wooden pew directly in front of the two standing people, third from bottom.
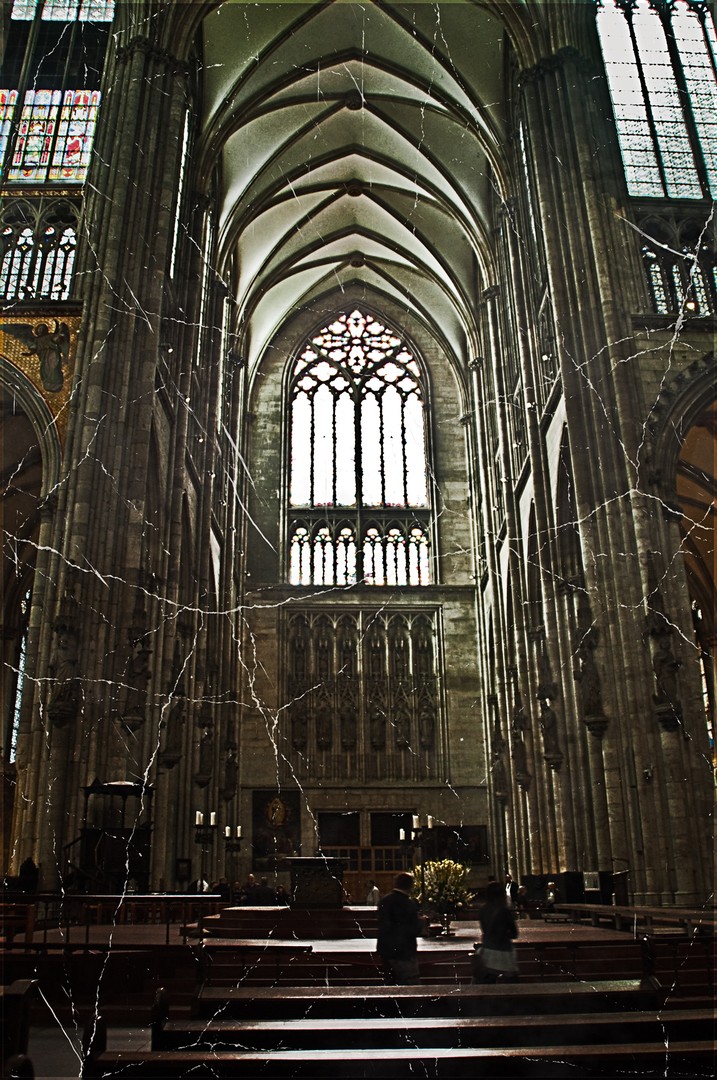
[192,980,662,1020]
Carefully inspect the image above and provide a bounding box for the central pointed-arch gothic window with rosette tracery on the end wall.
[288,311,431,585]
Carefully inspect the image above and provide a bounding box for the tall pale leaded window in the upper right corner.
[597,0,717,199]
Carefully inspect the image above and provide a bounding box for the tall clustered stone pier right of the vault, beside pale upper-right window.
[516,42,704,902]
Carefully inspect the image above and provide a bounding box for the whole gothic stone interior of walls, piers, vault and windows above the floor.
[0,0,717,905]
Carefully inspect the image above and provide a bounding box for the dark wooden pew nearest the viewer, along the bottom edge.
[82,1040,714,1080]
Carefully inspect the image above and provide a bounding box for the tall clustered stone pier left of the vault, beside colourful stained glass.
[13,5,204,885]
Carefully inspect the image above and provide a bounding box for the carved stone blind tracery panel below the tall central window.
[282,611,441,781]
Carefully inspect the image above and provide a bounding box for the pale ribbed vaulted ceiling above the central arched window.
[200,0,526,375]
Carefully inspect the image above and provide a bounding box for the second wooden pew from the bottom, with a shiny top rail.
[147,1008,717,1052]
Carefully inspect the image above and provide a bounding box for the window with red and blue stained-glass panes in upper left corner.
[0,0,114,185]
